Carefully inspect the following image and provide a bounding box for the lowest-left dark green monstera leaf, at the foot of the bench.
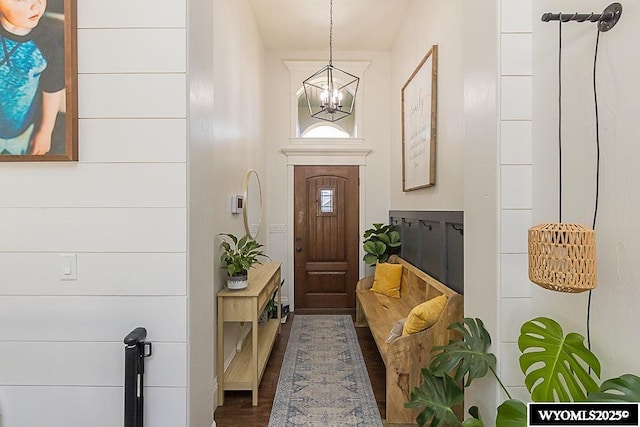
[404,368,464,427]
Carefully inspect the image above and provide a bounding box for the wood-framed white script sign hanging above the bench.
[402,45,438,191]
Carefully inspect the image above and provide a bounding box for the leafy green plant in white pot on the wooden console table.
[219,233,269,290]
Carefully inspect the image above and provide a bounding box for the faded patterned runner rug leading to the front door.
[269,315,382,427]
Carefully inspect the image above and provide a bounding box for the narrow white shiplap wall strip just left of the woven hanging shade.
[498,0,533,402]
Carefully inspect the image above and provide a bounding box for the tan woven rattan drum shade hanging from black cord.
[529,223,598,293]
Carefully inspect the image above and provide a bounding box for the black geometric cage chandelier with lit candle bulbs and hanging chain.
[302,0,360,122]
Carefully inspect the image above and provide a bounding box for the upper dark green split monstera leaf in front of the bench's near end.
[429,317,496,386]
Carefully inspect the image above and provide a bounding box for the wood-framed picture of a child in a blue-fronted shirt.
[0,0,78,161]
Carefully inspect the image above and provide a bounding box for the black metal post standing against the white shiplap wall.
[124,328,151,427]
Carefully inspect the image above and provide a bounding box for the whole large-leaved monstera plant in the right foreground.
[405,317,640,427]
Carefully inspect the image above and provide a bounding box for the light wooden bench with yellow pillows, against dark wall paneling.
[356,255,463,425]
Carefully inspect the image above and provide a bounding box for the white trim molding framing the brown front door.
[280,149,371,311]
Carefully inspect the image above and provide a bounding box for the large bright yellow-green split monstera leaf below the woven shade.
[518,317,600,402]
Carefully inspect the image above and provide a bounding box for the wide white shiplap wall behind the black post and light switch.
[0,0,187,427]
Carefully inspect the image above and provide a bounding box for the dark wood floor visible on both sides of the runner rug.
[214,313,385,427]
